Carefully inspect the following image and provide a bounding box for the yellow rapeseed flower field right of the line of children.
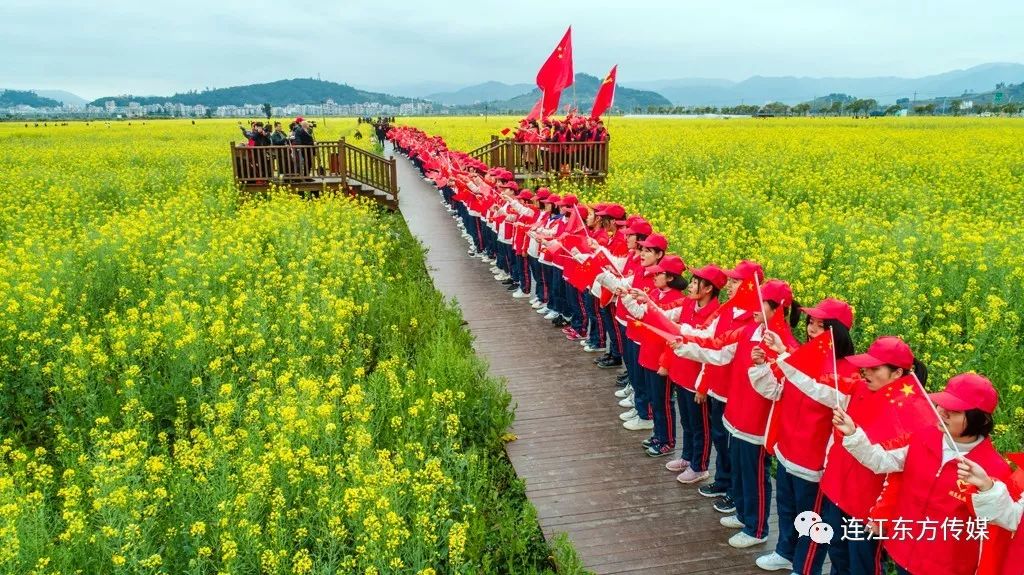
[403,117,1024,450]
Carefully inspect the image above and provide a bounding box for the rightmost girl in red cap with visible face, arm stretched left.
[834,373,1010,575]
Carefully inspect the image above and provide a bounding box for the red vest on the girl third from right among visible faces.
[774,358,858,478]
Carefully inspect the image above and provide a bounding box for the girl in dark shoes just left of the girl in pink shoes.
[624,255,686,457]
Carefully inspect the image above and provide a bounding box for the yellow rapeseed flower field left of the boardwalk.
[0,119,561,575]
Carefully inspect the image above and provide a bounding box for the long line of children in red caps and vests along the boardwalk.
[388,127,1024,575]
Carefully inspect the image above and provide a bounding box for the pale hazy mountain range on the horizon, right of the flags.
[634,63,1024,105]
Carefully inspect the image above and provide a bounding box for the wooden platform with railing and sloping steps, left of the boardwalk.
[231,138,398,210]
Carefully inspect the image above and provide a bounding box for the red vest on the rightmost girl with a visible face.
[885,427,1010,575]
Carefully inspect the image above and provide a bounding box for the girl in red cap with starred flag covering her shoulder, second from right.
[794,336,935,575]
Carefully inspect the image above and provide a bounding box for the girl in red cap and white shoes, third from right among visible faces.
[751,298,857,573]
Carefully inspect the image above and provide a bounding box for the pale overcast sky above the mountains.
[0,0,1024,98]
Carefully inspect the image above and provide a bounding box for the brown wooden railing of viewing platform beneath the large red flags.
[469,136,608,182]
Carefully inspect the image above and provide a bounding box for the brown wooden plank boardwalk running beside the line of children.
[397,145,775,574]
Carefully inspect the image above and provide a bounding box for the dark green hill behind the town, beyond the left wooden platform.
[91,78,414,106]
